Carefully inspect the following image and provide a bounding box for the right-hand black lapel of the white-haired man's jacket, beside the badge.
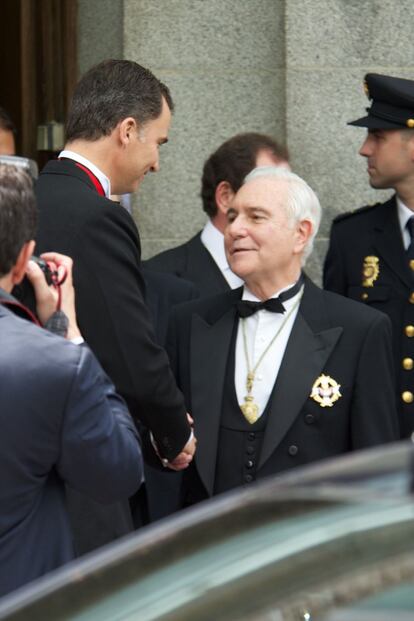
[259,280,342,468]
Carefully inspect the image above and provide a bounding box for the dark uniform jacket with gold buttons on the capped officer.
[324,197,414,437]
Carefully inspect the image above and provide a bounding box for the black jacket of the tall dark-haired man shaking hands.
[36,160,190,458]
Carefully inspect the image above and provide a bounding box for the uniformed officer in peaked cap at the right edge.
[324,73,414,438]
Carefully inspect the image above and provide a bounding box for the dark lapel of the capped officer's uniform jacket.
[374,196,412,288]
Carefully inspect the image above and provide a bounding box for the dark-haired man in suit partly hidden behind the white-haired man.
[146,133,289,297]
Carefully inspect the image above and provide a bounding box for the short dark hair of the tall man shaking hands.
[66,60,174,142]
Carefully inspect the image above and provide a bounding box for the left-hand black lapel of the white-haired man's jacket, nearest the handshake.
[190,289,241,495]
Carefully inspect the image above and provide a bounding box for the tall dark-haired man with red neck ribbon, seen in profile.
[36,60,195,549]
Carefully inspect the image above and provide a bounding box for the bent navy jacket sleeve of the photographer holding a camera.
[57,346,143,503]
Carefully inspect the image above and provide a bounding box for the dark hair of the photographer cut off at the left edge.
[0,164,37,276]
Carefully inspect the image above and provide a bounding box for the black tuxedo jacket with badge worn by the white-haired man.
[168,280,398,502]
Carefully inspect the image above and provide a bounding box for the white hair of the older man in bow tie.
[243,166,322,265]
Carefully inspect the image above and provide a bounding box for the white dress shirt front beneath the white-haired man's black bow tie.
[234,283,303,416]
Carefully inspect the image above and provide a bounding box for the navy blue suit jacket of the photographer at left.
[0,296,143,596]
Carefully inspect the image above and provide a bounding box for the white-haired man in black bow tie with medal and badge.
[168,167,398,503]
